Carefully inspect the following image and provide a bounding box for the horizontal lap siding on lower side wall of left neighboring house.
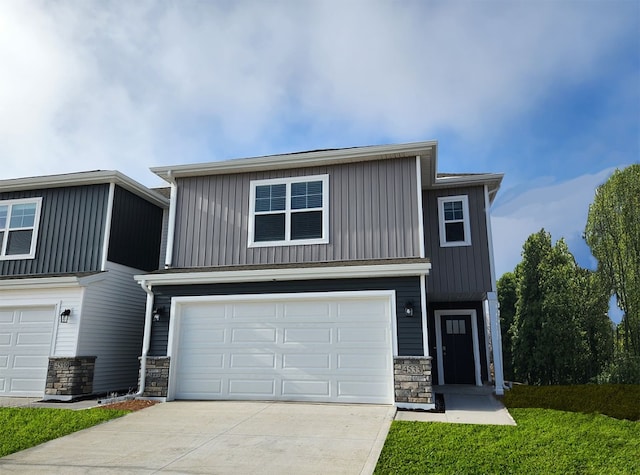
[77,261,147,393]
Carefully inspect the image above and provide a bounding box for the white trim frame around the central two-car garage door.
[167,290,398,401]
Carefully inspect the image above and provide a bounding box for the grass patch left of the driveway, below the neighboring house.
[0,407,129,457]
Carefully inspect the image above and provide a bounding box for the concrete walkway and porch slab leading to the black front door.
[395,386,516,426]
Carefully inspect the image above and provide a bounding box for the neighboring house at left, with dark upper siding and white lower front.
[0,171,168,400]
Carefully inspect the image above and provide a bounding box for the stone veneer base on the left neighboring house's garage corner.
[44,356,96,401]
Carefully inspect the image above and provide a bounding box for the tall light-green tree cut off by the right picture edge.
[585,164,640,357]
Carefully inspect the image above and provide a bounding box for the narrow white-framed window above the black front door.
[438,195,471,247]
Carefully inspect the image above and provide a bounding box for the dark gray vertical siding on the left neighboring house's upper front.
[0,184,109,276]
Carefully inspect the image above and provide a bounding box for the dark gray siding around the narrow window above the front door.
[422,186,491,299]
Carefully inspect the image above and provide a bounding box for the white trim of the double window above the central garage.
[248,175,329,248]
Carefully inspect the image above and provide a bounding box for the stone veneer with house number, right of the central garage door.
[393,356,434,407]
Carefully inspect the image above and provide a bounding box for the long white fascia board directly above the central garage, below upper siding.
[138,263,431,285]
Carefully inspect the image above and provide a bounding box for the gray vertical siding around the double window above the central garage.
[172,158,420,267]
